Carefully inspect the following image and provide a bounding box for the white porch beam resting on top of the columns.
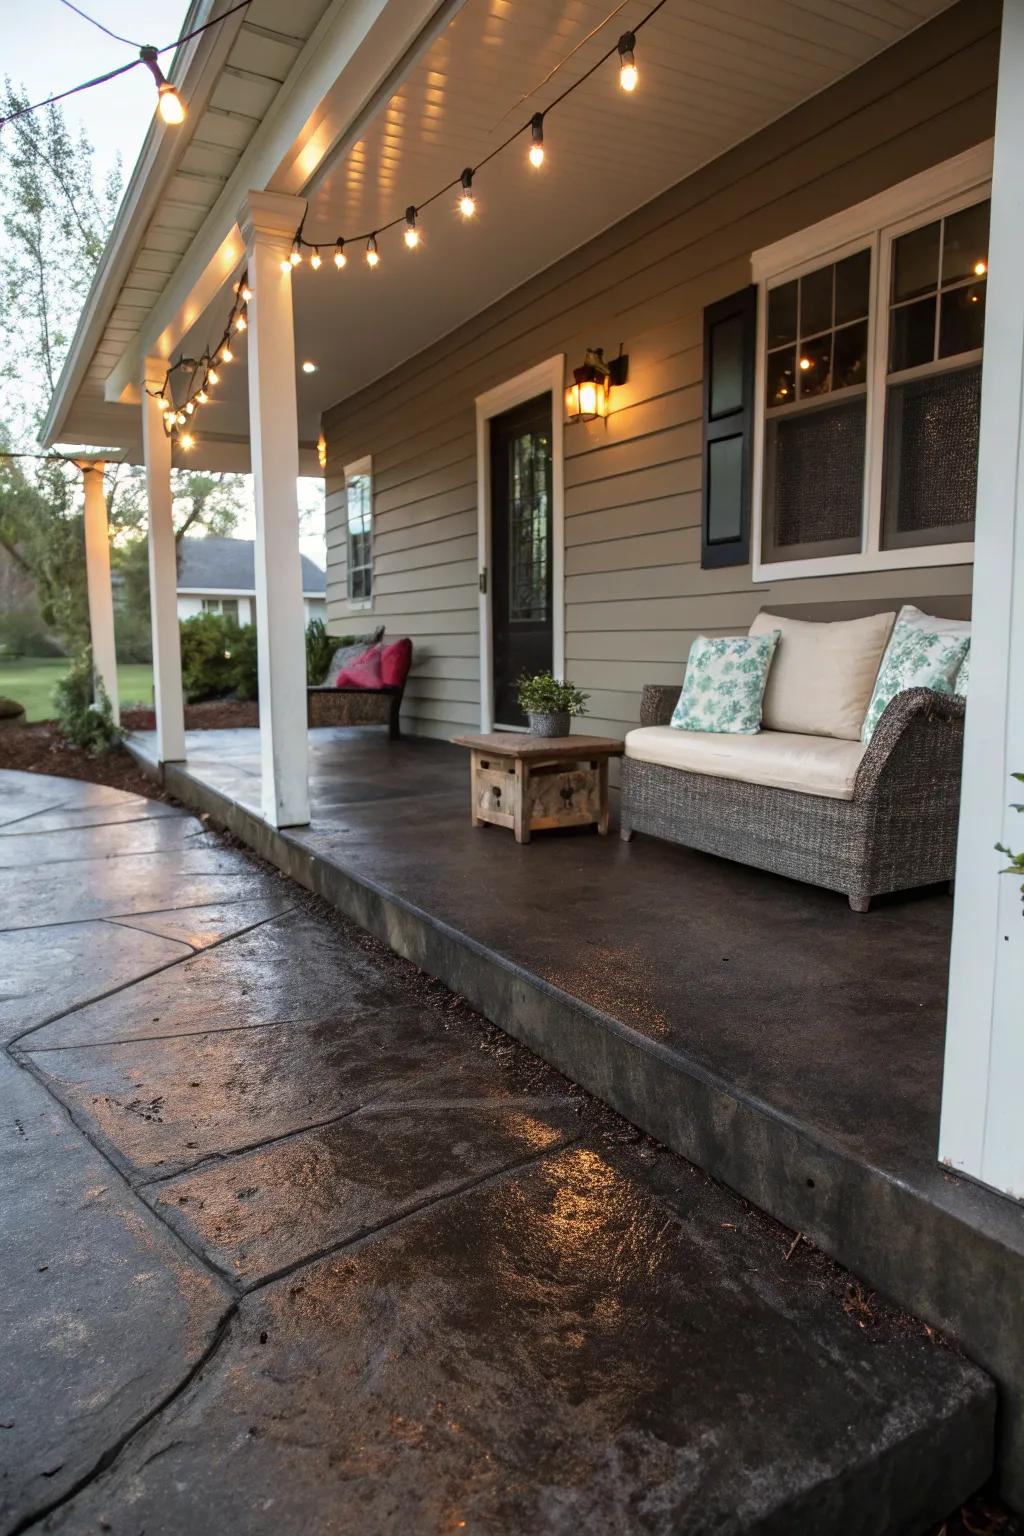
[104,0,464,401]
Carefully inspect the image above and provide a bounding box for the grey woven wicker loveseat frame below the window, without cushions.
[622,687,964,912]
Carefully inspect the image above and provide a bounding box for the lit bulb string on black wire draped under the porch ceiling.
[132,0,668,452]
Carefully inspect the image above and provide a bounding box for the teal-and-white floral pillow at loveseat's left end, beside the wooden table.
[672,630,780,736]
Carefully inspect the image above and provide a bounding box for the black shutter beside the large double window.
[700,284,757,570]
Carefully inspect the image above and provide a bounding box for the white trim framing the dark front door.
[476,352,565,731]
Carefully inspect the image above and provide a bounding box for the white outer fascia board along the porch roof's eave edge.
[40,0,244,445]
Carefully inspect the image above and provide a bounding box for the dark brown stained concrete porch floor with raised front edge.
[125,730,1024,1507]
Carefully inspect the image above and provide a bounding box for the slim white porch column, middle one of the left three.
[143,358,184,763]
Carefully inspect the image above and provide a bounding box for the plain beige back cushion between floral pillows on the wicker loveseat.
[751,613,895,742]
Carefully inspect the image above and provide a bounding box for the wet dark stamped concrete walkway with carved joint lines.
[0,774,993,1536]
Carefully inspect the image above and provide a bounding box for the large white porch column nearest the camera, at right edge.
[940,0,1024,1200]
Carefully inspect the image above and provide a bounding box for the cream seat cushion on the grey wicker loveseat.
[626,725,866,800]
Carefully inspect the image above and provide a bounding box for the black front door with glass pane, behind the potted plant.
[490,395,554,727]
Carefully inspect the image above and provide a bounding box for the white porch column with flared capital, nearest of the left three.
[238,192,309,826]
